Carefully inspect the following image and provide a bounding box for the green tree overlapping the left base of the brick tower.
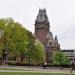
[26,32,45,63]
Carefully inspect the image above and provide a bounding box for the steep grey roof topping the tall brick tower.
[36,9,49,23]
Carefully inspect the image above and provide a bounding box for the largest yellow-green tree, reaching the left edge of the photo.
[0,18,27,61]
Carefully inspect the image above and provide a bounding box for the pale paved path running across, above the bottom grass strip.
[0,66,75,74]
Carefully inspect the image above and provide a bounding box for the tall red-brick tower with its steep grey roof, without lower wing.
[35,9,50,45]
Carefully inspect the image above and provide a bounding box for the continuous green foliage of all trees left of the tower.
[0,18,45,62]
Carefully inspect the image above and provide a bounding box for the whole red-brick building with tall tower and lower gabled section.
[35,9,60,62]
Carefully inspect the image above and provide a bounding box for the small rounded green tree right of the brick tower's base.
[53,51,69,65]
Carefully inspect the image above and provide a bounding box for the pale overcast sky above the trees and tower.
[0,0,75,49]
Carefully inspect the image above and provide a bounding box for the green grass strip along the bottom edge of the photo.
[0,72,75,75]
